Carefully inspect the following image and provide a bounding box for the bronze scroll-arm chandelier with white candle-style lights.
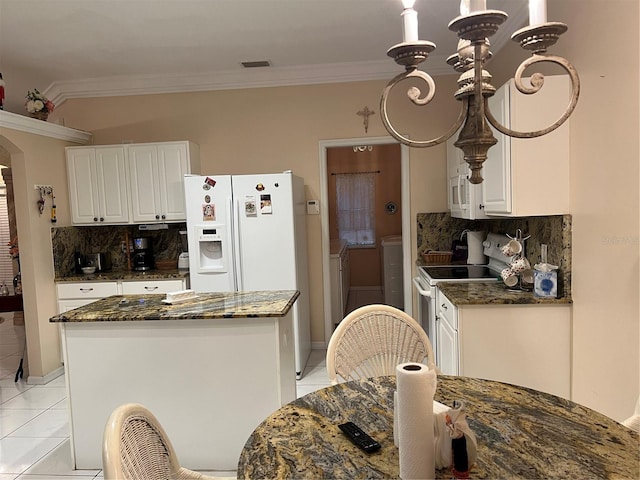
[380,0,580,183]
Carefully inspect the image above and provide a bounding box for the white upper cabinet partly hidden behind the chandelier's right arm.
[480,75,571,217]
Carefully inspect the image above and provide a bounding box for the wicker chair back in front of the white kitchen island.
[102,403,219,480]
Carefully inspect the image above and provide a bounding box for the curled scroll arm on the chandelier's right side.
[484,54,580,138]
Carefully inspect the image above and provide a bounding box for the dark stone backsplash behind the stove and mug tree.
[417,212,571,298]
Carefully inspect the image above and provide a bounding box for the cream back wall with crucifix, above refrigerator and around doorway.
[52,77,457,343]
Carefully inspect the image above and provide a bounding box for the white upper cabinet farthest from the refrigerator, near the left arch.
[66,146,129,225]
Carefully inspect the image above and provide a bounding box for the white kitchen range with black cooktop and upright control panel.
[413,233,510,368]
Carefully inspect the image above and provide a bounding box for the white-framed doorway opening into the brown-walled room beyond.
[319,137,412,344]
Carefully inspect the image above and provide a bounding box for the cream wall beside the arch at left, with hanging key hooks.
[0,128,69,377]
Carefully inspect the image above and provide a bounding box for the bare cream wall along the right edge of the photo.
[489,0,640,420]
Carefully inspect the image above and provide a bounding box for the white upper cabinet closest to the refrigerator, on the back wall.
[128,142,199,223]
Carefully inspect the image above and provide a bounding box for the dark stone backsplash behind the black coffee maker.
[51,223,186,277]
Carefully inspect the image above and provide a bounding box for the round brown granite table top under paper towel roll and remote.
[237,375,640,479]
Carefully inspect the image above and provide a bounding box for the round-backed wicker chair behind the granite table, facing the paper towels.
[327,305,436,385]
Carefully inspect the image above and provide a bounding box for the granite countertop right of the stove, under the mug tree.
[438,281,572,306]
